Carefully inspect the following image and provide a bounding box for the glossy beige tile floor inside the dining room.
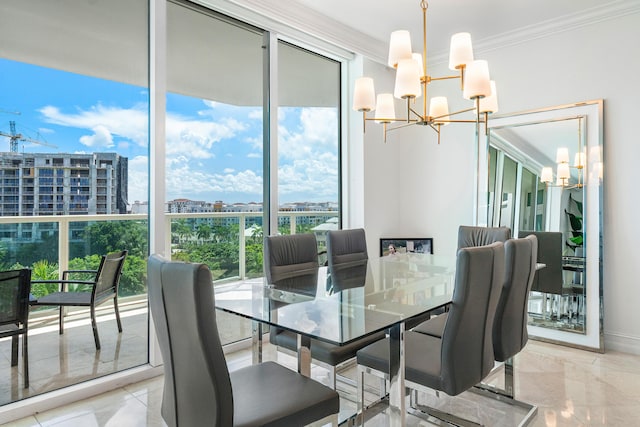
[1,340,640,427]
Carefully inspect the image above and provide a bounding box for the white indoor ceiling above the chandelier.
[288,0,627,56]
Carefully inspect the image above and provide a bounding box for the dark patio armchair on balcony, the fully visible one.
[30,250,127,350]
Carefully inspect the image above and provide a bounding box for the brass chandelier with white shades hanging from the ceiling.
[353,0,498,144]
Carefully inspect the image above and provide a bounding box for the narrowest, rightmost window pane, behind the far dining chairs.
[278,41,340,253]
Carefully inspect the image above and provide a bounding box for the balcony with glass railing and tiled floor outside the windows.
[0,212,337,405]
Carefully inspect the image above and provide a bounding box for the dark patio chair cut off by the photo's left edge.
[0,268,31,388]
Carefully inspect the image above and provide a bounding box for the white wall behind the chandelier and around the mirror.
[365,13,640,354]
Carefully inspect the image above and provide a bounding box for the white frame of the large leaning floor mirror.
[474,99,604,352]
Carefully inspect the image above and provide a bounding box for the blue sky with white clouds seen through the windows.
[0,59,338,203]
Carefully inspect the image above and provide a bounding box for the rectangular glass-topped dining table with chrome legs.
[215,253,455,426]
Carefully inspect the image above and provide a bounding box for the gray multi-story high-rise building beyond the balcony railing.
[0,153,128,216]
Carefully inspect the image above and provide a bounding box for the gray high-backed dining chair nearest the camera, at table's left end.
[148,255,340,427]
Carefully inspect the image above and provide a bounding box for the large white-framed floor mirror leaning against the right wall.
[477,100,604,351]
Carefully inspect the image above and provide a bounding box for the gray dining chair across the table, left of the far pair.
[264,233,384,389]
